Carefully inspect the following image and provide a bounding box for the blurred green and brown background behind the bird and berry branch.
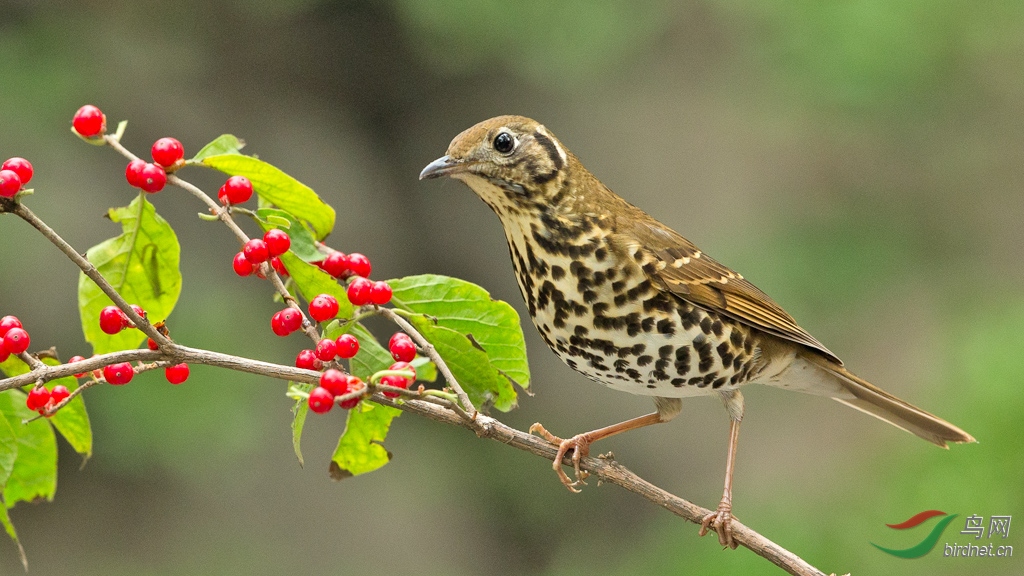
[0,0,1024,575]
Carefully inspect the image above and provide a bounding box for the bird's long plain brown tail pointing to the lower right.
[802,354,977,448]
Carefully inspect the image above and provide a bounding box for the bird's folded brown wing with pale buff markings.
[616,214,843,365]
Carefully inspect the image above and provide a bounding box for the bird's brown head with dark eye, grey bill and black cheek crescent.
[420,116,575,216]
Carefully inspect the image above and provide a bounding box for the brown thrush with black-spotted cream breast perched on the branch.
[420,116,976,548]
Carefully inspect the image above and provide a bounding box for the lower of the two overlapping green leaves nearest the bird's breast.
[411,316,516,412]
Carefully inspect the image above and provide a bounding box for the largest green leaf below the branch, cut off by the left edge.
[0,389,57,508]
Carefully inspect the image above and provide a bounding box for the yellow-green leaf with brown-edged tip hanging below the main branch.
[331,402,401,480]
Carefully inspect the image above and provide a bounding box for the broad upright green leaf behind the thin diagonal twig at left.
[78,195,181,354]
